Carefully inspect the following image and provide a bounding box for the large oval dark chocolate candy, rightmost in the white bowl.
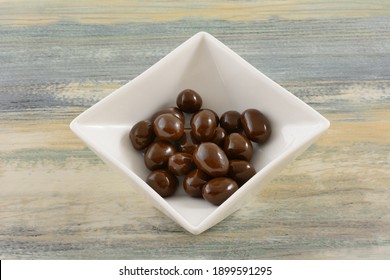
[241,109,271,144]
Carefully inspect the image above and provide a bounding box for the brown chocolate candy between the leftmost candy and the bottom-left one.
[144,140,176,170]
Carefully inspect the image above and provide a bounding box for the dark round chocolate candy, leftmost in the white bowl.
[129,120,155,150]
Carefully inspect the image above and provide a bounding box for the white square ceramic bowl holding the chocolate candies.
[70,32,329,234]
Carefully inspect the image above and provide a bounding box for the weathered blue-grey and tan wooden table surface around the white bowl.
[0,0,390,259]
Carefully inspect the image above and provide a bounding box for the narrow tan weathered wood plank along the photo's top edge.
[0,0,390,25]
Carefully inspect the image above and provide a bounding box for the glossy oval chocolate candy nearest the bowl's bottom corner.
[202,177,238,205]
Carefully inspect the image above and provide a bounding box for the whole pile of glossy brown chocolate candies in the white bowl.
[129,89,271,205]
